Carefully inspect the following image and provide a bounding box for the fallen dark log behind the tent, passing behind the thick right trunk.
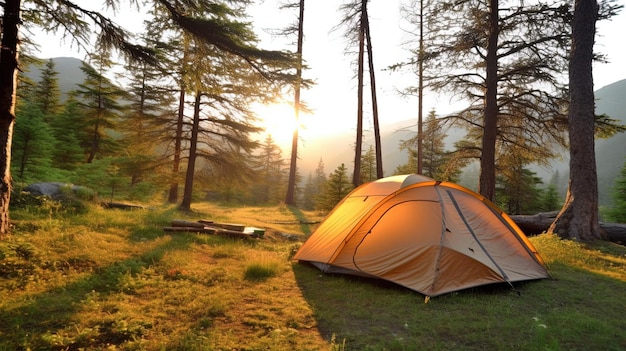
[509,212,626,245]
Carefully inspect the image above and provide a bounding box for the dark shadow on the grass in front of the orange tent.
[293,263,626,350]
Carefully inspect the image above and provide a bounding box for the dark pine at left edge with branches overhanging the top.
[0,0,295,238]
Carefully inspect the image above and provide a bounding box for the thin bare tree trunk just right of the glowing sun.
[285,0,304,205]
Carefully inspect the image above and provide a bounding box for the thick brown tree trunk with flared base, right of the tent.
[549,0,604,241]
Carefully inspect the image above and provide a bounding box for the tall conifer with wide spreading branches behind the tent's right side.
[428,0,570,199]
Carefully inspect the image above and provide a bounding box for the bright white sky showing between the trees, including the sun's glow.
[30,0,626,145]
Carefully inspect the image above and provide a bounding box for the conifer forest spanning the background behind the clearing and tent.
[0,0,625,239]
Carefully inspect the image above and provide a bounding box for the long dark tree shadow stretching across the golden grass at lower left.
[0,232,193,350]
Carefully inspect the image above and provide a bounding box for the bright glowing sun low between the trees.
[256,103,297,149]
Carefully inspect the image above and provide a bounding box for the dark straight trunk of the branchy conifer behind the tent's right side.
[478,0,500,201]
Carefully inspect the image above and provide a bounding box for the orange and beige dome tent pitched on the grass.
[294,174,549,296]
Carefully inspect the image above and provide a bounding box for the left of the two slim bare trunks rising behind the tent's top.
[352,0,367,188]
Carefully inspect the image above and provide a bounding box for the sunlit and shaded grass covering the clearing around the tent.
[0,203,626,351]
